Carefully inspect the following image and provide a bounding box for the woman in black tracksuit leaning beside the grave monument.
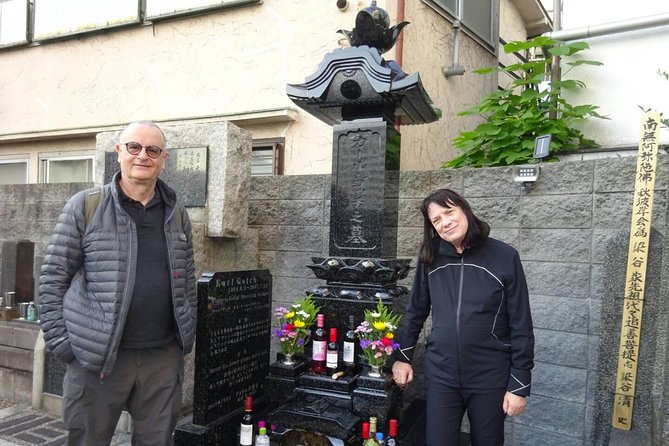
[393,189,534,446]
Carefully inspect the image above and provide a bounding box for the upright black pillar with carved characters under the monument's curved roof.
[330,118,397,257]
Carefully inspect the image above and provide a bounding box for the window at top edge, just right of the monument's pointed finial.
[427,0,498,49]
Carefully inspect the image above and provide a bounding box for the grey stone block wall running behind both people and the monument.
[0,156,669,446]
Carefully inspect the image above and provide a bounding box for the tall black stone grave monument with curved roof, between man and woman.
[267,2,439,445]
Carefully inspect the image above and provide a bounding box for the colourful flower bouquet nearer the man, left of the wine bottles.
[272,295,320,365]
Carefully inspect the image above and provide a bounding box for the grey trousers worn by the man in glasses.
[63,342,184,446]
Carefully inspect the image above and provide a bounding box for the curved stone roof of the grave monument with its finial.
[286,1,441,125]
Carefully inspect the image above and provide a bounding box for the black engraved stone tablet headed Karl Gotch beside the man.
[193,270,272,426]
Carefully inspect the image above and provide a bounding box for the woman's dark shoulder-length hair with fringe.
[418,189,490,265]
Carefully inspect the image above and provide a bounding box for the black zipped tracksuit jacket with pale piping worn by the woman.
[394,238,534,396]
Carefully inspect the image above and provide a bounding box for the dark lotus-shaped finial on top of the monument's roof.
[337,0,409,54]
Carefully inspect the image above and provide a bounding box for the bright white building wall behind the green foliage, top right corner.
[562,0,669,148]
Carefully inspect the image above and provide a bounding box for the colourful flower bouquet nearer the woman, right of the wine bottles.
[355,301,402,378]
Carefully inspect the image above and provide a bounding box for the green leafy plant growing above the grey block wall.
[442,36,608,168]
